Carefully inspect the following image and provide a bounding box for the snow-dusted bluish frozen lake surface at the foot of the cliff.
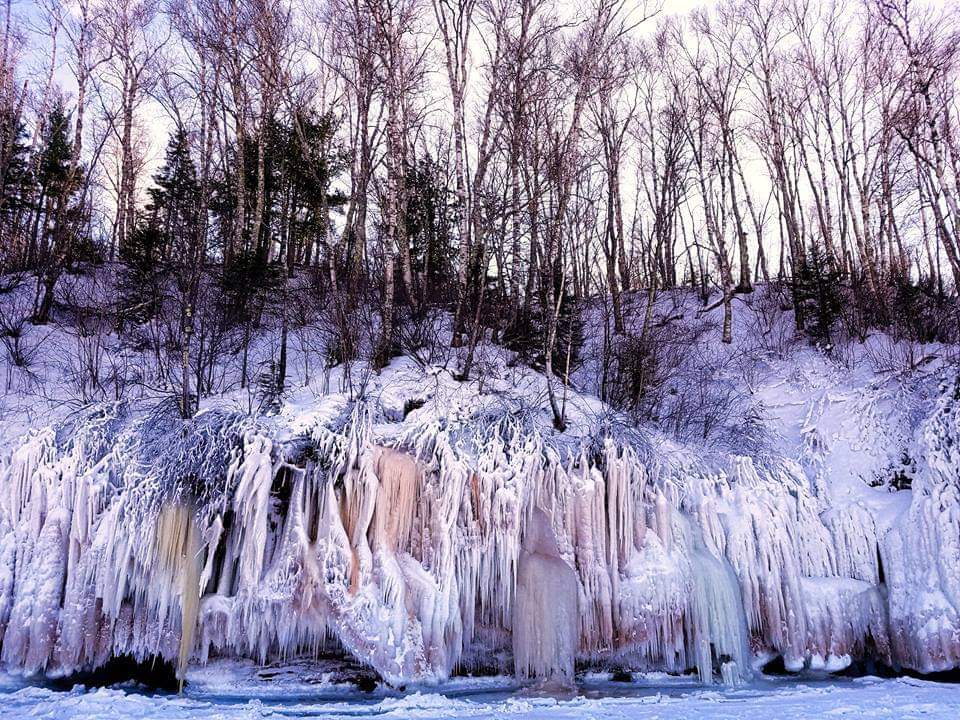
[0,668,960,720]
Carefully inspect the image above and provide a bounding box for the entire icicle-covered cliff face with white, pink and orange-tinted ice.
[0,368,960,683]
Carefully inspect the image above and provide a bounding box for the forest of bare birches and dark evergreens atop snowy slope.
[0,0,960,429]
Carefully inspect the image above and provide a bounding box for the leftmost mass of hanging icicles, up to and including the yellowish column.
[0,406,262,675]
